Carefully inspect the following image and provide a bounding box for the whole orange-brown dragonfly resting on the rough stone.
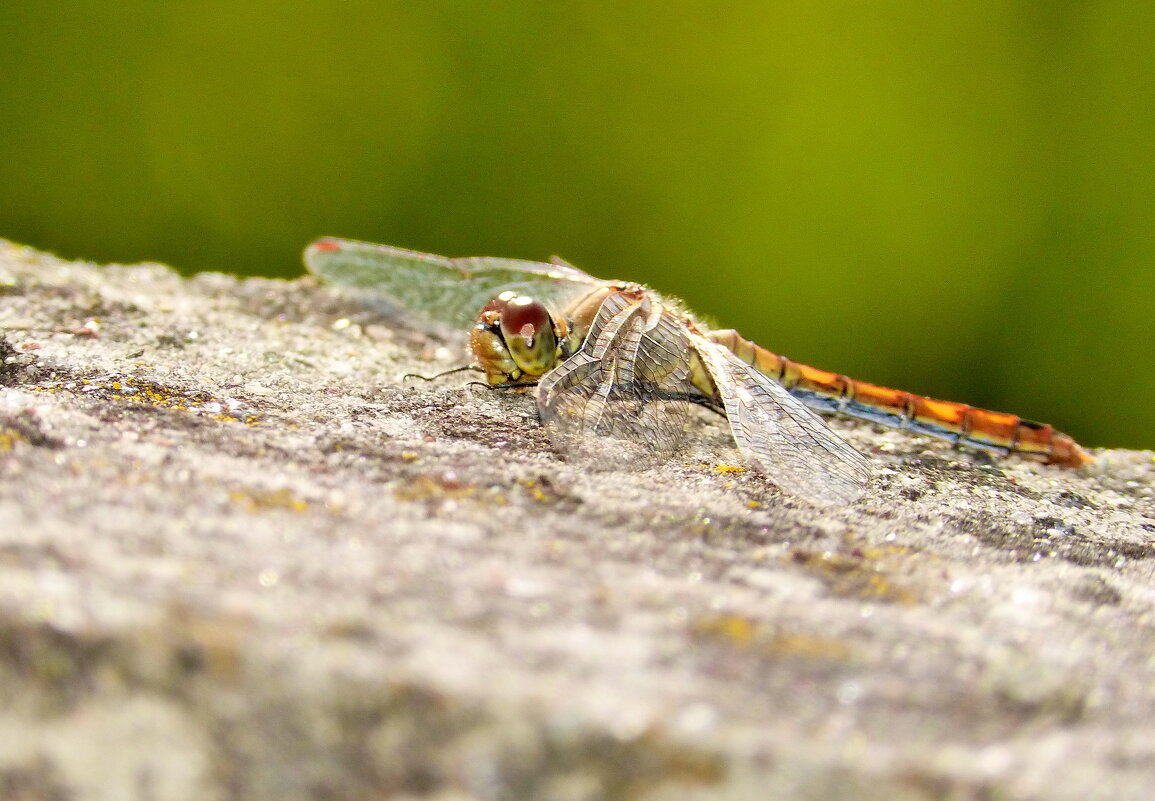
[304,237,1093,507]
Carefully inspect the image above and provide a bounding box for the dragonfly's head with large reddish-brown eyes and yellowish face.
[469,291,566,384]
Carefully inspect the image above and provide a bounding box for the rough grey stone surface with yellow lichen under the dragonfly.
[0,244,1155,801]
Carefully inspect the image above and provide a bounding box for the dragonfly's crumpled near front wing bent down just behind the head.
[537,292,701,467]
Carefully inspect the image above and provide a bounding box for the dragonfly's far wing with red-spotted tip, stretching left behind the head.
[305,237,602,332]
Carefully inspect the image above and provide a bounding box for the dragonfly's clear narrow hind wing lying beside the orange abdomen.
[690,334,870,506]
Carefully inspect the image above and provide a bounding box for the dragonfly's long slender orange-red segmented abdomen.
[709,329,1094,467]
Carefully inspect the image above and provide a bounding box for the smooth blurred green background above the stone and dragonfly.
[0,0,1155,448]
